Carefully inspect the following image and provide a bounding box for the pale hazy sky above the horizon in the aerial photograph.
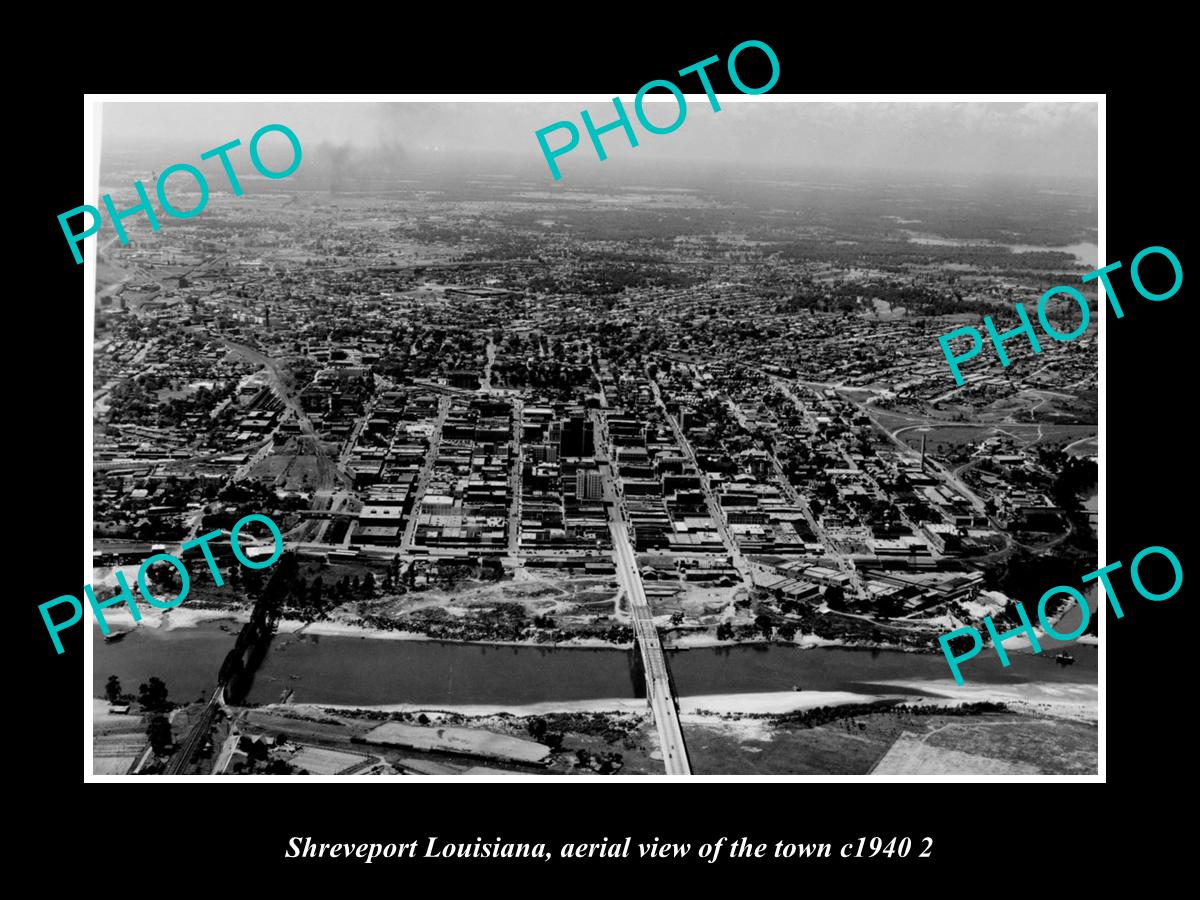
[102,100,1098,178]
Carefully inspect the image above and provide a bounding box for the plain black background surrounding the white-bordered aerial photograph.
[21,22,1195,893]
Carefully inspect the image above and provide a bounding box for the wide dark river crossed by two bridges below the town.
[92,622,1097,706]
